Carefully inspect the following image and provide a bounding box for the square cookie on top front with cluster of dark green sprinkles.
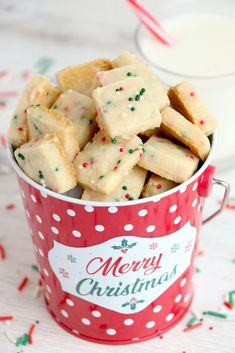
[93,77,162,139]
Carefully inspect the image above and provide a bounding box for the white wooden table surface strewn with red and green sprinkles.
[0,0,235,353]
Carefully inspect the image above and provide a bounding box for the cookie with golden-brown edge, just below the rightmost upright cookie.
[161,107,210,161]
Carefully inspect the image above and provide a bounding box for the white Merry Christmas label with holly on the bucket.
[48,222,196,314]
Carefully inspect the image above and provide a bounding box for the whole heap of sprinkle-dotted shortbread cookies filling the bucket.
[8,52,217,202]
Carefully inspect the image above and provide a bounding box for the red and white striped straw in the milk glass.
[127,0,173,45]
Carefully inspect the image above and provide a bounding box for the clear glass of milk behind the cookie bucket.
[135,0,235,169]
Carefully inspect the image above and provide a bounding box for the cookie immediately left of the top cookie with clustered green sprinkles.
[52,89,97,150]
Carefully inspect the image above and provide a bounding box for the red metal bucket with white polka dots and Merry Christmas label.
[9,135,229,344]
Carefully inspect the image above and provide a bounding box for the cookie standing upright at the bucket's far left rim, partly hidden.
[8,75,60,147]
